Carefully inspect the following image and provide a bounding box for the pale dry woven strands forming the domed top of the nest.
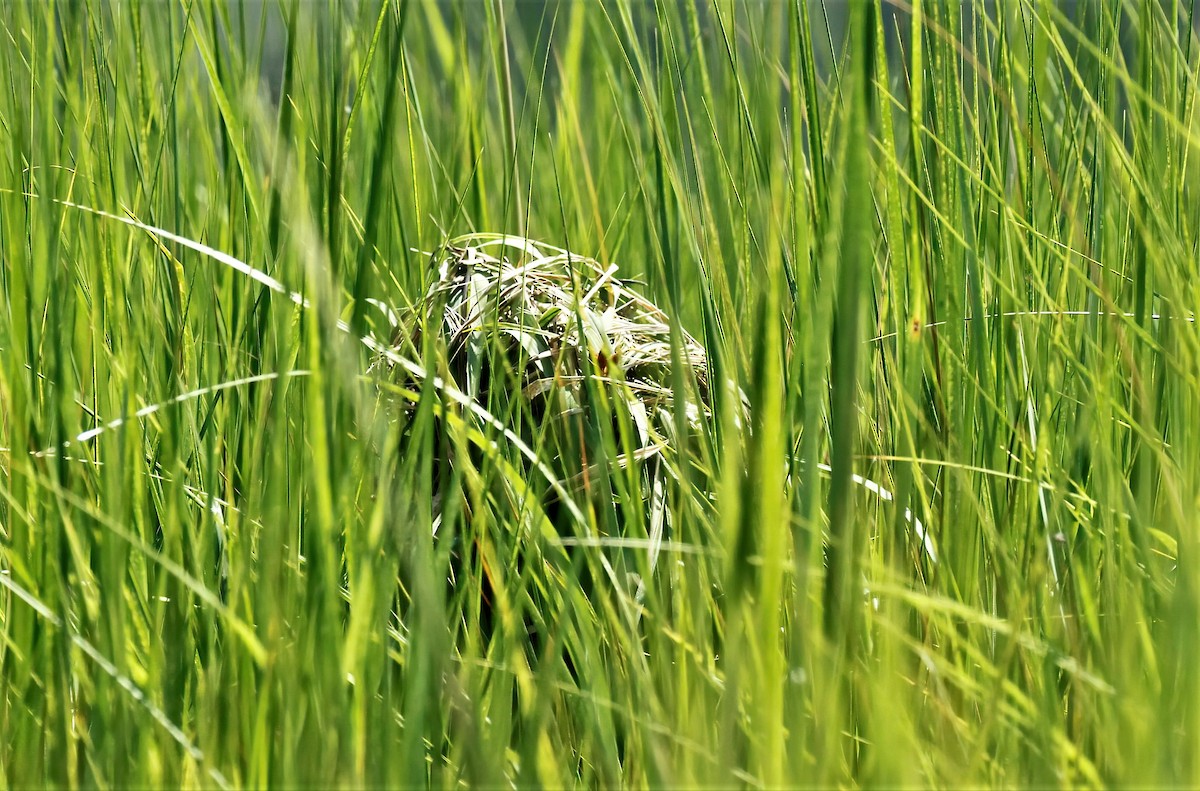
[380,234,710,455]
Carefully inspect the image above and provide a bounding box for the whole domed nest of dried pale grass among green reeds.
[377,234,713,539]
